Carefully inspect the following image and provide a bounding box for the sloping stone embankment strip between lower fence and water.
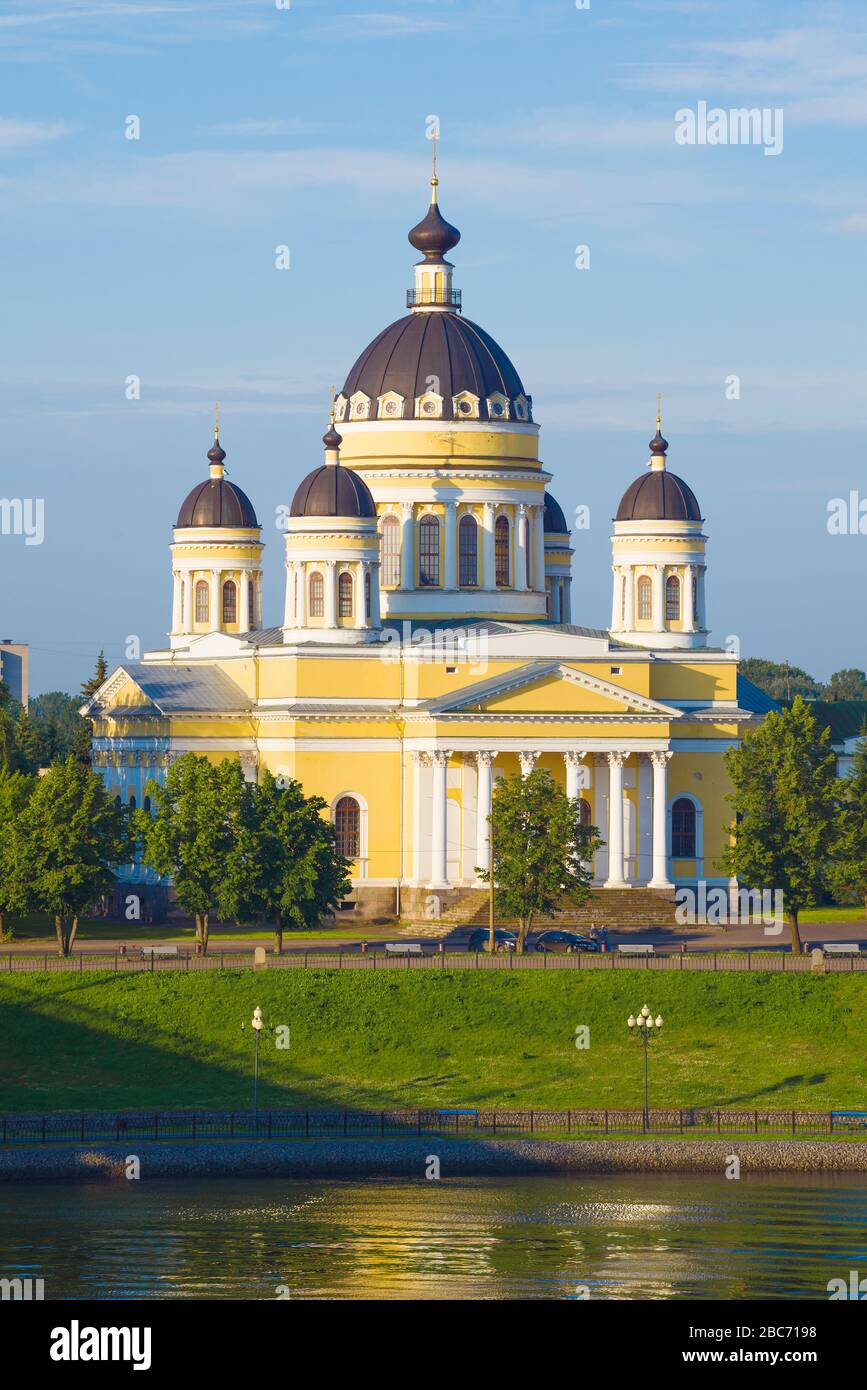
[0,1136,867,1184]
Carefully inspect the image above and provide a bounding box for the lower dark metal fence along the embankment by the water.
[0,1106,867,1144]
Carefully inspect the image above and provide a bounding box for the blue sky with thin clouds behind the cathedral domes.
[0,0,867,694]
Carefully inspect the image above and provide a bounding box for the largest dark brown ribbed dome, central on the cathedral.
[343,313,529,420]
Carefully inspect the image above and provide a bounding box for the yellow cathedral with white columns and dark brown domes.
[82,172,770,917]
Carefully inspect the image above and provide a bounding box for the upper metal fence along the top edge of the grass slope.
[0,948,867,976]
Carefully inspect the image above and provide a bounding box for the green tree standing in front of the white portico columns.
[477,769,603,952]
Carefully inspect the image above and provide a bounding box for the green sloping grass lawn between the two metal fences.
[0,970,867,1111]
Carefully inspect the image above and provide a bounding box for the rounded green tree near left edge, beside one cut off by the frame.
[18,758,131,956]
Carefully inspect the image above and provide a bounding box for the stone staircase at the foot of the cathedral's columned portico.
[427,888,677,935]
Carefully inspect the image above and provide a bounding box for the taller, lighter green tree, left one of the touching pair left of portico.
[133,753,244,955]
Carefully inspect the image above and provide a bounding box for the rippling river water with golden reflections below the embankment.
[0,1175,867,1300]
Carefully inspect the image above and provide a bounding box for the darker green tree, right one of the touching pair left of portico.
[236,769,350,954]
